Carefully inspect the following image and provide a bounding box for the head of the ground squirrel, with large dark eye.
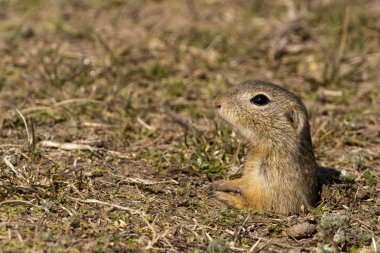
[215,81,311,146]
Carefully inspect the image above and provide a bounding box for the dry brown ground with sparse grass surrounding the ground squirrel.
[0,0,380,252]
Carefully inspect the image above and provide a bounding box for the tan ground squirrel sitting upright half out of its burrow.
[213,81,317,214]
